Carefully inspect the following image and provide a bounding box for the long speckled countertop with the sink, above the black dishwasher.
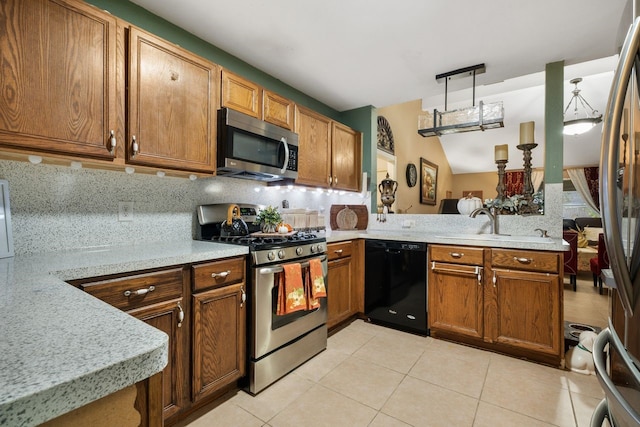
[326,229,569,252]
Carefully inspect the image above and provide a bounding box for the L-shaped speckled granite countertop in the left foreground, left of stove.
[0,240,248,426]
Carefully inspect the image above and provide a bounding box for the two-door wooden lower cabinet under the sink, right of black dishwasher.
[428,245,564,366]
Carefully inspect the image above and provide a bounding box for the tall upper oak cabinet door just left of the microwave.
[127,28,219,172]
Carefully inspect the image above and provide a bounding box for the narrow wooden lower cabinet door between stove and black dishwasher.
[327,257,353,328]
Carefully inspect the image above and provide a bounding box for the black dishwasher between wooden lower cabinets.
[364,240,429,335]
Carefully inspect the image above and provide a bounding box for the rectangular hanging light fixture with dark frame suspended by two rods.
[418,64,504,137]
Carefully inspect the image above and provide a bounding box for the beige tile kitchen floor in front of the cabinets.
[180,320,603,427]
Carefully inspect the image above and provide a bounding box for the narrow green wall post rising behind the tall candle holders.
[544,61,564,184]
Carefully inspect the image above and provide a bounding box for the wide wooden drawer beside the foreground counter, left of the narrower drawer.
[80,268,182,311]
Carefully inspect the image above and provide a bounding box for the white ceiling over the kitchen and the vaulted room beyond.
[127,0,631,173]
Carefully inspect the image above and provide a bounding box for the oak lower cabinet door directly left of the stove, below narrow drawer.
[192,282,246,402]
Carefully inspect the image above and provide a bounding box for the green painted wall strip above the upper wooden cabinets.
[85,0,342,120]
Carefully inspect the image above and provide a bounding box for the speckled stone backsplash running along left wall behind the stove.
[0,160,369,255]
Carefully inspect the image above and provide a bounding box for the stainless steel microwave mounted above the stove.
[216,108,298,181]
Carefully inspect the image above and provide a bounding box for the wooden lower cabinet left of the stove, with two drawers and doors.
[76,256,246,426]
